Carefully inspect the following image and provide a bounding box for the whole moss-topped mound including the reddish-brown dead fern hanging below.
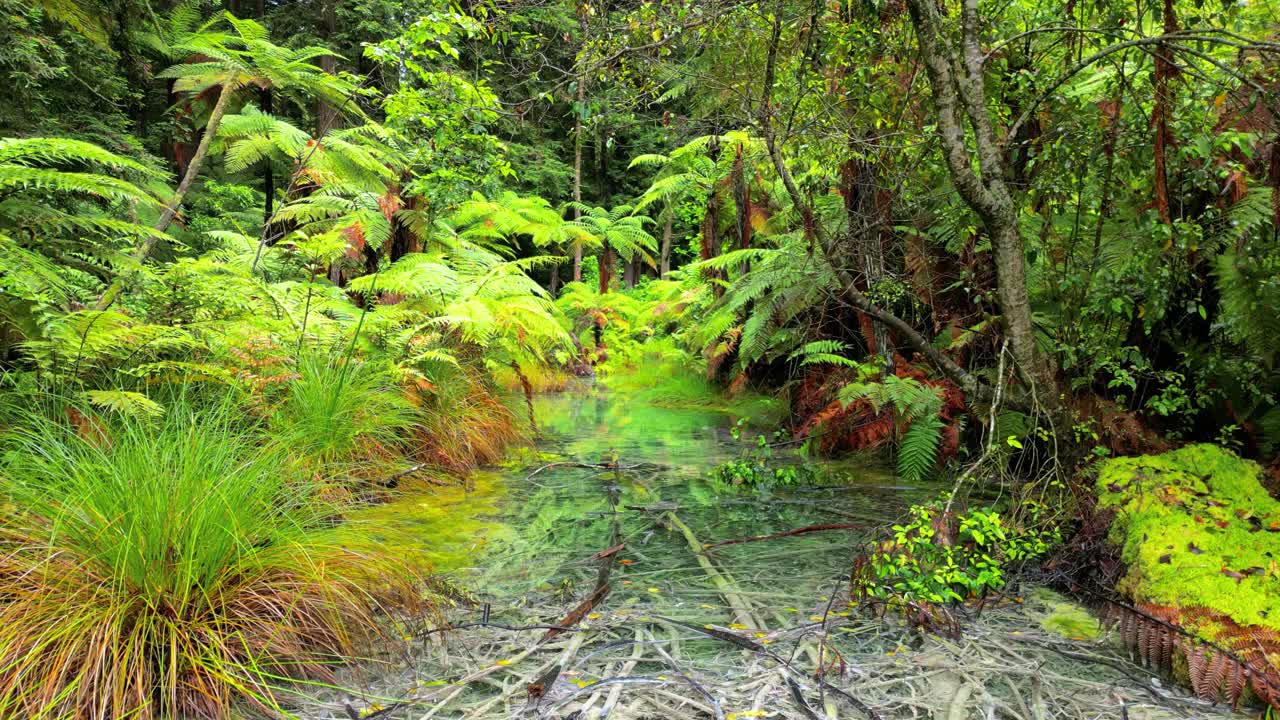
[1097,445,1280,710]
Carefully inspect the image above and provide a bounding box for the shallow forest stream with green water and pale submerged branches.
[298,386,1243,720]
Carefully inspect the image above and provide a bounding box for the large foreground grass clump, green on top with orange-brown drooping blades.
[0,404,420,720]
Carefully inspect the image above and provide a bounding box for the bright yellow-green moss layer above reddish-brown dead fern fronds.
[1097,445,1280,638]
